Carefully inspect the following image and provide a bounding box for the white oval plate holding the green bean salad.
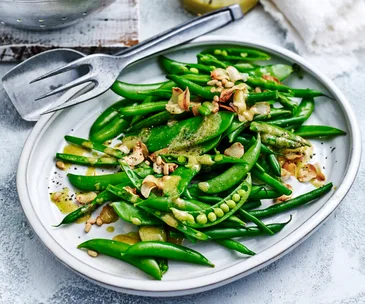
[17,37,361,296]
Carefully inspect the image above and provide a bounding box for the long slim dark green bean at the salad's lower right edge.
[250,183,333,218]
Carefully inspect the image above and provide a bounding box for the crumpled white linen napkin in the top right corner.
[261,0,365,77]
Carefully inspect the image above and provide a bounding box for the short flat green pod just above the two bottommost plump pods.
[110,202,161,226]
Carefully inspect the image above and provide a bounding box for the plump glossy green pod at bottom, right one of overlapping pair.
[124,241,214,267]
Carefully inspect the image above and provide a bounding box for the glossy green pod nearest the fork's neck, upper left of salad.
[111,80,171,101]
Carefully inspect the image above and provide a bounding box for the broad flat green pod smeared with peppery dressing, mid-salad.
[123,112,233,152]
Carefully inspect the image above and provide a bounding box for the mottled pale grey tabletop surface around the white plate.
[0,0,365,304]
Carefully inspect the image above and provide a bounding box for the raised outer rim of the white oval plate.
[17,35,362,297]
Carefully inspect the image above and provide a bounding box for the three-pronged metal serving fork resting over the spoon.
[31,4,243,114]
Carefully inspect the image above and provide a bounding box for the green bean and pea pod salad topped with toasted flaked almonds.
[51,46,345,280]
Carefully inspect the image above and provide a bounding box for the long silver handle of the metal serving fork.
[116,4,243,65]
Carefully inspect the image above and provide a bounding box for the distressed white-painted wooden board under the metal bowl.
[0,0,139,62]
